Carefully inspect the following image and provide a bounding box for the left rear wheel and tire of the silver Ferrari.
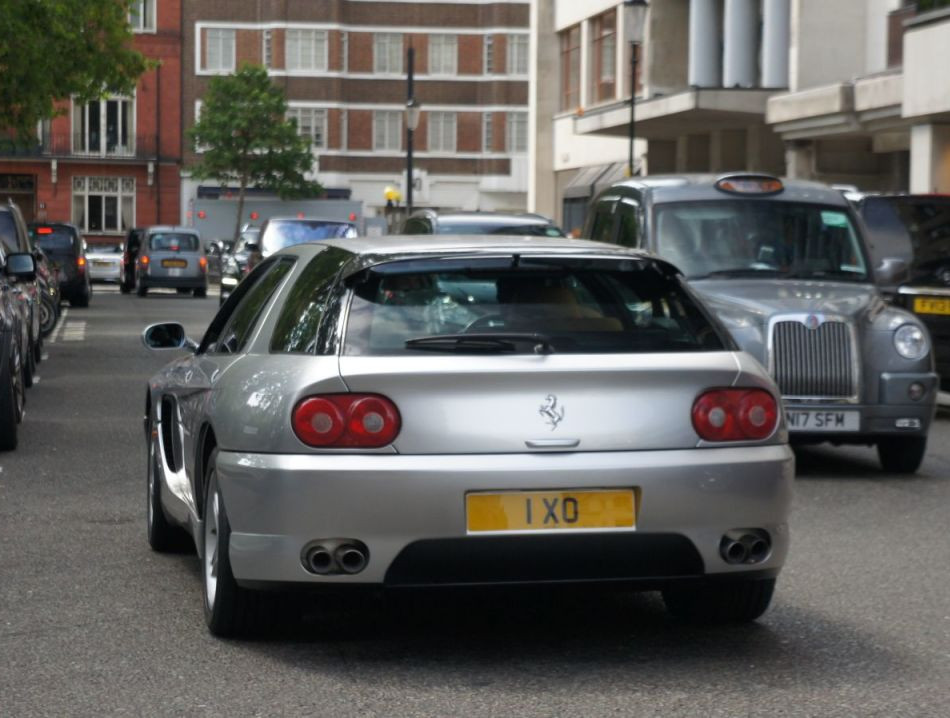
[201,449,264,638]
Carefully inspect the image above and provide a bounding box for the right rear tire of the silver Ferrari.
[663,578,775,624]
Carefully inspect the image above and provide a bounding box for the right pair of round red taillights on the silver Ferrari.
[692,389,778,441]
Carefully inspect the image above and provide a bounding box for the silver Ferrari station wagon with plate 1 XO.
[143,237,794,636]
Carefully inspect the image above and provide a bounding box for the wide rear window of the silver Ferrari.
[343,256,728,355]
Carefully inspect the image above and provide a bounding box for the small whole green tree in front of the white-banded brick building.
[188,65,323,238]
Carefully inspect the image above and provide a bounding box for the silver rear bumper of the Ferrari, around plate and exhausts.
[217,445,794,586]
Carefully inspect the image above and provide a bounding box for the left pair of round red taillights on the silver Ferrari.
[291,394,402,449]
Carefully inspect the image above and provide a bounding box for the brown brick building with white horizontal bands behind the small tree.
[181,0,529,228]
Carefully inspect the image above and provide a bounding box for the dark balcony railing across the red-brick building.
[0,133,158,160]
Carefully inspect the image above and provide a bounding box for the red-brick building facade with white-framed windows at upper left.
[0,0,182,244]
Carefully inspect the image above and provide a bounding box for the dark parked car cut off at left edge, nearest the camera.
[0,249,36,451]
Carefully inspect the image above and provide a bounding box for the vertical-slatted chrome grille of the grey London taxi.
[772,320,857,399]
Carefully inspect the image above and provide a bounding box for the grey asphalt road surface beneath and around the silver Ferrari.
[0,290,950,716]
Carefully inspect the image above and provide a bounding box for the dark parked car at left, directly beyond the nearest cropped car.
[0,201,43,387]
